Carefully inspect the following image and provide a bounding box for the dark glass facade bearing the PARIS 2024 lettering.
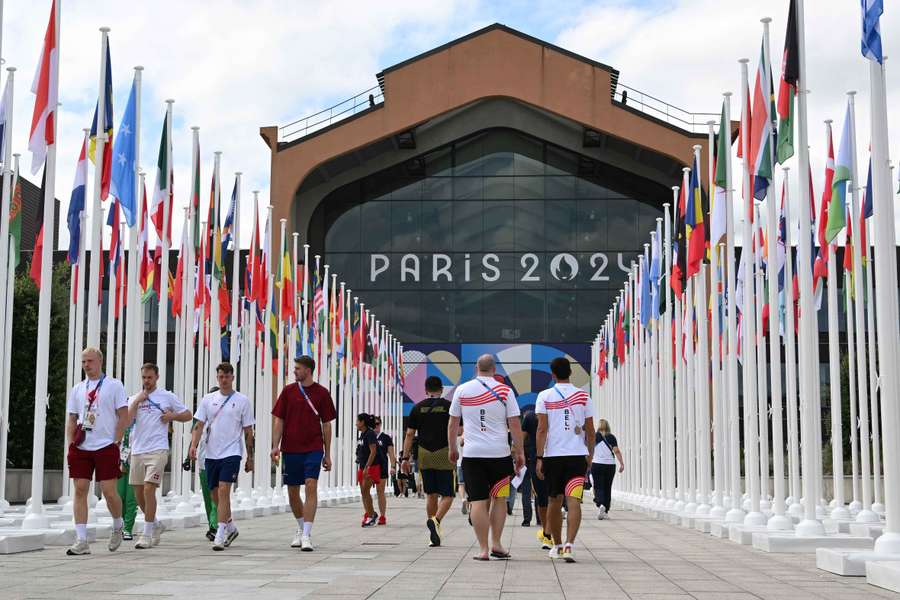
[310,129,671,343]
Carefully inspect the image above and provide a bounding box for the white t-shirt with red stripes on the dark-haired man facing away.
[534,383,594,457]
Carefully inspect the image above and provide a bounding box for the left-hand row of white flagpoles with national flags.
[0,0,403,516]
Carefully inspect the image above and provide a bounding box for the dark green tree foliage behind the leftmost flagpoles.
[7,262,69,469]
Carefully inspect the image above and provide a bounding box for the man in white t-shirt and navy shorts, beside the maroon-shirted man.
[189,362,256,551]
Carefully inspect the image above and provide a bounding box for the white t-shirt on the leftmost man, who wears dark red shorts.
[66,376,128,450]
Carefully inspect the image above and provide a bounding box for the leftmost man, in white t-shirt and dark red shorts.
[66,348,128,556]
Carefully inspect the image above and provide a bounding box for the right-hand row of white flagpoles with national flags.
[592,0,900,553]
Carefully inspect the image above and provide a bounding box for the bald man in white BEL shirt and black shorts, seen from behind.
[447,354,525,561]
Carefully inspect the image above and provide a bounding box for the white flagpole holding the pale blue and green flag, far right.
[848,91,881,523]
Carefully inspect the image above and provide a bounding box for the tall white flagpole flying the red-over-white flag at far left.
[22,5,61,529]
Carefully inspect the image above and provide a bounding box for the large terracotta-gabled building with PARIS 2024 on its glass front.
[260,24,718,406]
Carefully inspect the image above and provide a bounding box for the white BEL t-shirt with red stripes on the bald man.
[450,377,519,458]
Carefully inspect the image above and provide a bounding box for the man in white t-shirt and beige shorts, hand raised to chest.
[128,363,191,550]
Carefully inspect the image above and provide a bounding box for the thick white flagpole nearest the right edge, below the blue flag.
[869,51,900,554]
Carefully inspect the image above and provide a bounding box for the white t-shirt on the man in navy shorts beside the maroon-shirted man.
[195,392,256,459]
